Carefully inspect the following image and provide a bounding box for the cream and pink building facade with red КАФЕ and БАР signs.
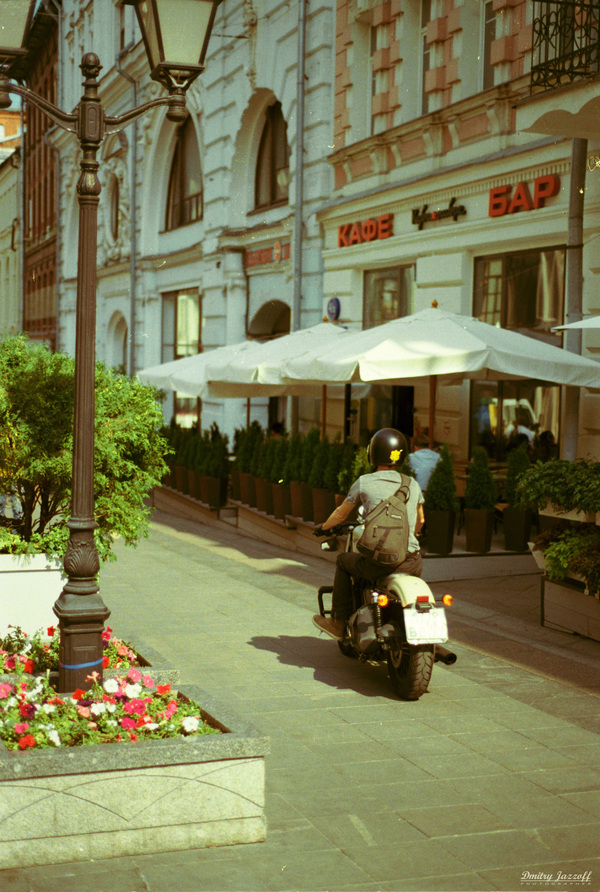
[317,0,600,457]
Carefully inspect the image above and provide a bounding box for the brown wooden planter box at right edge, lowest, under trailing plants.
[540,576,600,641]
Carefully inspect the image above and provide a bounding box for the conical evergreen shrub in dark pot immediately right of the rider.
[425,444,460,554]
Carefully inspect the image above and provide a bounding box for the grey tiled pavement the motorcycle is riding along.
[0,517,600,892]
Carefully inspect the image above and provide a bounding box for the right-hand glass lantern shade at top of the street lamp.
[125,0,221,89]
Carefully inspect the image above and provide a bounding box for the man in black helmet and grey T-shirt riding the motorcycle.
[313,427,425,641]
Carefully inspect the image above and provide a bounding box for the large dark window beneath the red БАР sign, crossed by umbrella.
[470,248,565,460]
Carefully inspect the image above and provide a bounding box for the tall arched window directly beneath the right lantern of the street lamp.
[165,118,202,230]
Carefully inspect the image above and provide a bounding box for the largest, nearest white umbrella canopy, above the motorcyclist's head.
[281,308,600,387]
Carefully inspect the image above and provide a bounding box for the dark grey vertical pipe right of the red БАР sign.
[562,139,587,461]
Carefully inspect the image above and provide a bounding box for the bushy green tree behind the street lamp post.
[0,336,169,560]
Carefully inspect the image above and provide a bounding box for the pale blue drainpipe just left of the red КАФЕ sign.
[290,0,307,433]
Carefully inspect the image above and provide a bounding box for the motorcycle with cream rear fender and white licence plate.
[318,520,456,700]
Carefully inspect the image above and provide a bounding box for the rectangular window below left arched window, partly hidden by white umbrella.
[161,288,202,427]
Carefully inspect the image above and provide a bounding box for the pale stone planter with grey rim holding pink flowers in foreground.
[0,688,269,869]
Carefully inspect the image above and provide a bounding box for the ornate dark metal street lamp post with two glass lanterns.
[0,0,221,692]
